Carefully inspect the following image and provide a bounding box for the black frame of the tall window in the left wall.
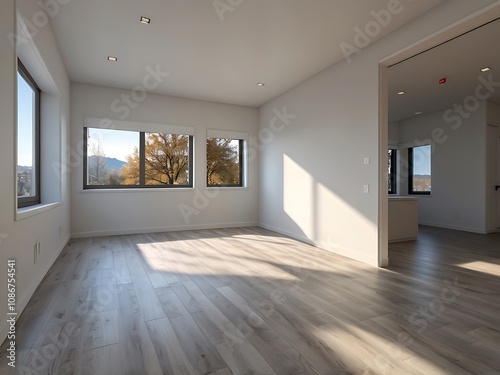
[16,59,42,208]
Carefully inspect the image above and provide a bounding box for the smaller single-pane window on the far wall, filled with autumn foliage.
[207,137,244,187]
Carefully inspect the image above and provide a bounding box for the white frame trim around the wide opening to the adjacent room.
[378,1,500,267]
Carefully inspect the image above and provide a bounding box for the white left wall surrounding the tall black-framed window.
[0,0,70,342]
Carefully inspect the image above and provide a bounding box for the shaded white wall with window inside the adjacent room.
[400,106,486,233]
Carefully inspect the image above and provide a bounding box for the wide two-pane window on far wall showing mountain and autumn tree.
[83,127,193,189]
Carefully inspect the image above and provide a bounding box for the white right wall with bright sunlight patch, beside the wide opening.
[260,0,493,265]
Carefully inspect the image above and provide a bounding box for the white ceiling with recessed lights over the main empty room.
[47,0,443,106]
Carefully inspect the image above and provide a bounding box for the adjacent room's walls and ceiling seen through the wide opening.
[388,16,500,244]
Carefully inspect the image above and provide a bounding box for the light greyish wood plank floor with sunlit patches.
[0,227,500,375]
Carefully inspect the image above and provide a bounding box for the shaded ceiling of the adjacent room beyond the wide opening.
[388,20,500,122]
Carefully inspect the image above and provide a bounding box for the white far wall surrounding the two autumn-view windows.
[71,84,259,237]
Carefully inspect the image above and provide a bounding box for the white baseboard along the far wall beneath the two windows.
[71,222,259,238]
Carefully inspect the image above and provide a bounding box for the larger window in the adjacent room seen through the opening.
[408,145,431,194]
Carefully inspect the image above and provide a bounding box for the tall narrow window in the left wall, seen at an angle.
[17,60,40,208]
